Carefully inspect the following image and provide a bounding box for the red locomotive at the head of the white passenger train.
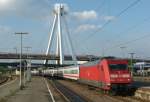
[79,59,132,91]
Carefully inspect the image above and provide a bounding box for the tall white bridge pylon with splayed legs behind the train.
[44,4,77,65]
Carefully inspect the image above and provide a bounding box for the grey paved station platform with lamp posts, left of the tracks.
[7,77,52,102]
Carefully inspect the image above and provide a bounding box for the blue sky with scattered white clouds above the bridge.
[0,0,150,58]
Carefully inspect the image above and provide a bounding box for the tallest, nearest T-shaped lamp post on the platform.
[15,32,28,90]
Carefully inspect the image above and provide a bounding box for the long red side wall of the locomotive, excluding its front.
[79,61,110,90]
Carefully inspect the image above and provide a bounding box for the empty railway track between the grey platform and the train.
[48,80,91,102]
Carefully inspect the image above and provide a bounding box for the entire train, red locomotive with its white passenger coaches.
[40,59,132,94]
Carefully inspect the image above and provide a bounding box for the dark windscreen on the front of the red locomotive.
[109,64,128,70]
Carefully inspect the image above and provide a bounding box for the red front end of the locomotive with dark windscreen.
[108,60,132,91]
